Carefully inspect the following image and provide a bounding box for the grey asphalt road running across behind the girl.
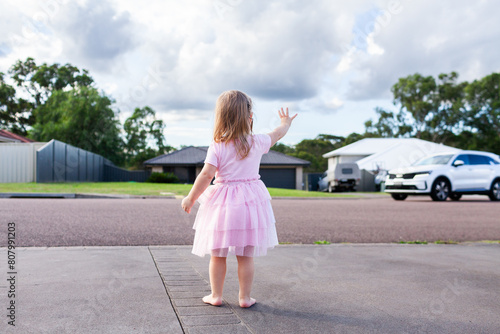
[0,196,500,247]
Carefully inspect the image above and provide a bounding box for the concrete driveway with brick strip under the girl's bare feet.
[0,244,500,334]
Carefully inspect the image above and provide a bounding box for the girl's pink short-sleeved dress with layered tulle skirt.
[192,134,278,257]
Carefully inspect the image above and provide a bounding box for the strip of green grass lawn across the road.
[0,182,368,197]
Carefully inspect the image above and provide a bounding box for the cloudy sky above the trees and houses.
[0,0,500,147]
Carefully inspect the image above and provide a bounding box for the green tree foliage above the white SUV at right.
[365,72,500,154]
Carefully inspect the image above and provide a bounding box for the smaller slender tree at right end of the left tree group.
[123,106,174,169]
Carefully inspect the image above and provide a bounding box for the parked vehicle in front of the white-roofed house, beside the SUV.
[318,163,361,192]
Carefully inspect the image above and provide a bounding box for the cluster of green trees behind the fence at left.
[0,58,173,168]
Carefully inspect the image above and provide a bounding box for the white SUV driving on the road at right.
[385,151,500,201]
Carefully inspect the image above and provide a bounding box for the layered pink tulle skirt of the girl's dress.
[192,179,278,257]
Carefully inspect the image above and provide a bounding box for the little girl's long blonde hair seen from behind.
[214,90,253,159]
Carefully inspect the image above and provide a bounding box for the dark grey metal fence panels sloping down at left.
[36,139,149,182]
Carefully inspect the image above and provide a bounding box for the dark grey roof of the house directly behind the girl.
[144,146,311,167]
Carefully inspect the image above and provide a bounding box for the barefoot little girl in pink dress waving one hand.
[182,90,297,307]
